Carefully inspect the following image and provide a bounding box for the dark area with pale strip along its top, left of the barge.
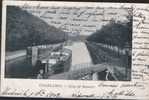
[5,56,34,78]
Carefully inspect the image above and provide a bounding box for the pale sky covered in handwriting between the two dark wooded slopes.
[23,6,129,35]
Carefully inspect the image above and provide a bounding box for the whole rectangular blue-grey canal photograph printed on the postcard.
[5,4,133,81]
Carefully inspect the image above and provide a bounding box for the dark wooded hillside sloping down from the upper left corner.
[6,6,66,51]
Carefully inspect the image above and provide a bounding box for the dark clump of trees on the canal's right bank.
[87,17,132,48]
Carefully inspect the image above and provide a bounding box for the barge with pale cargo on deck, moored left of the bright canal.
[27,45,72,78]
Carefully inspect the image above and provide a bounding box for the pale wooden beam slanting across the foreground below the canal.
[47,63,118,81]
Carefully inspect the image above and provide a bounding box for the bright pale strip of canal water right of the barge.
[65,42,92,70]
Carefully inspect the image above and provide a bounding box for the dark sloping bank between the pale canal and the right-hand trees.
[86,41,131,80]
